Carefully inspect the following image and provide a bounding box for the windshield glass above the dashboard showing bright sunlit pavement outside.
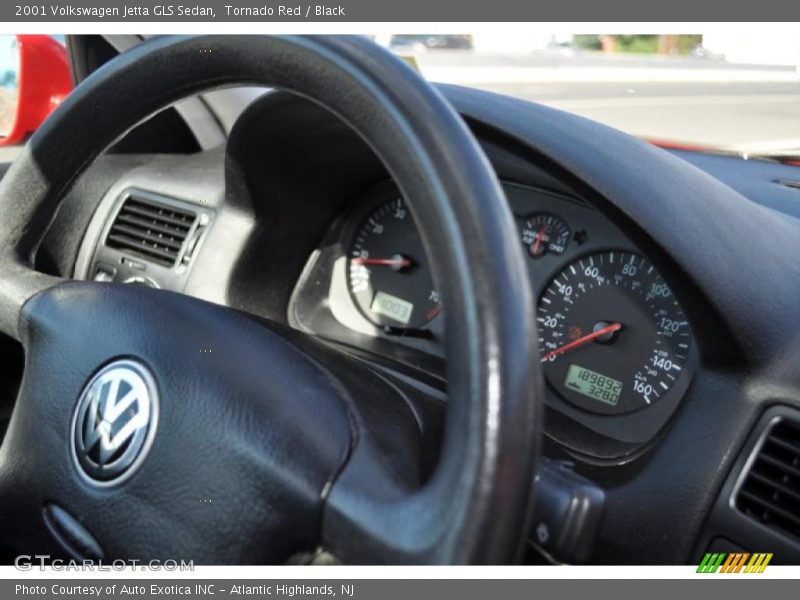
[376,27,800,157]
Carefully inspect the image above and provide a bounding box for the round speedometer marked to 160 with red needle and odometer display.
[537,250,692,414]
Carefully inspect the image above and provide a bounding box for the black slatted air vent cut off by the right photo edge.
[736,418,800,538]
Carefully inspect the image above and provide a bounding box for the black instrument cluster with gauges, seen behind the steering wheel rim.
[289,176,697,461]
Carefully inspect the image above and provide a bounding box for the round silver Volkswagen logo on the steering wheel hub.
[70,360,158,486]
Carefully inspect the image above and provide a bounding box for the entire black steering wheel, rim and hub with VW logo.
[0,36,541,564]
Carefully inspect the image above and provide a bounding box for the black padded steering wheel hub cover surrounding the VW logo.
[0,283,350,564]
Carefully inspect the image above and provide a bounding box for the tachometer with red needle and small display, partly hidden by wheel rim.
[348,198,441,330]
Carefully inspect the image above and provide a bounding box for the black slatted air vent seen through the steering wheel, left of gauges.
[106,194,197,267]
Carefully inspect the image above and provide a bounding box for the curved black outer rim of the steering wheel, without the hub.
[0,36,542,563]
